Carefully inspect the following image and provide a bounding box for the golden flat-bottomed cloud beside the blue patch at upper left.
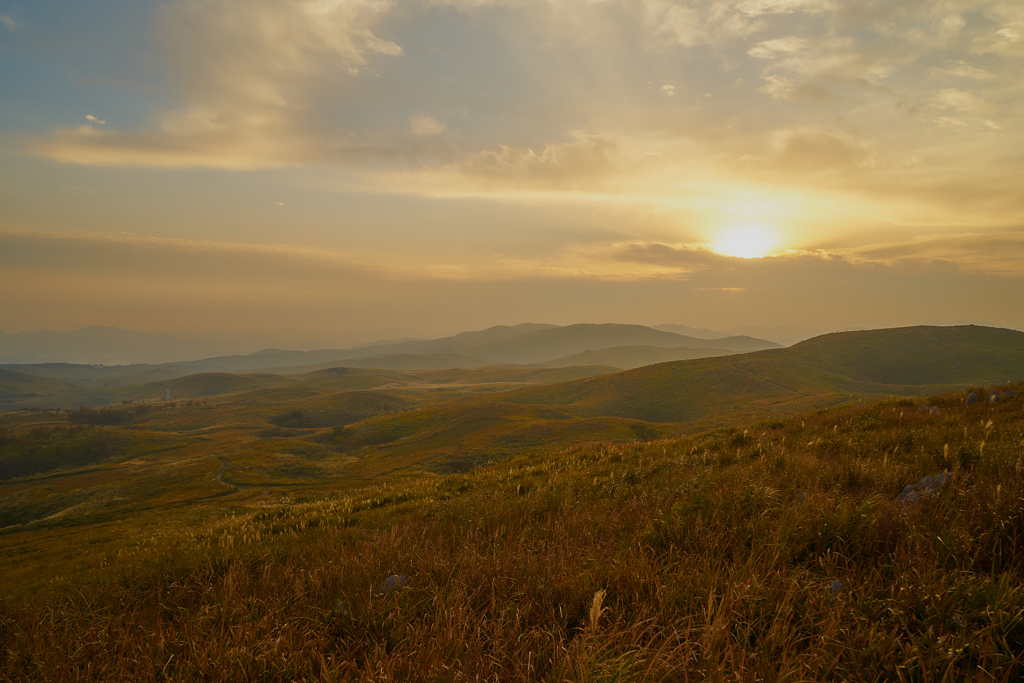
[35,0,402,169]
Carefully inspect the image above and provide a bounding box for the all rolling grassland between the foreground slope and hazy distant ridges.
[0,327,1024,530]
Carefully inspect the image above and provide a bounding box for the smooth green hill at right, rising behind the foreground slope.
[491,326,1024,422]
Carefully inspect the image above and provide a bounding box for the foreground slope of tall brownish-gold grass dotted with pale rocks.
[0,385,1024,683]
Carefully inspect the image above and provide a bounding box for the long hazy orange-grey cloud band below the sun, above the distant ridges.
[0,224,1024,332]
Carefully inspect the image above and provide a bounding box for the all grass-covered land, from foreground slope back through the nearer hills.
[0,328,1024,683]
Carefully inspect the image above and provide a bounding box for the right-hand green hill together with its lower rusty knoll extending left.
[317,326,1024,473]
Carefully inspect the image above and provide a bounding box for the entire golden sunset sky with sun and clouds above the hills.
[0,0,1024,335]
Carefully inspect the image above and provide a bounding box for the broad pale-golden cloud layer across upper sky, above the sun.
[19,0,1024,239]
